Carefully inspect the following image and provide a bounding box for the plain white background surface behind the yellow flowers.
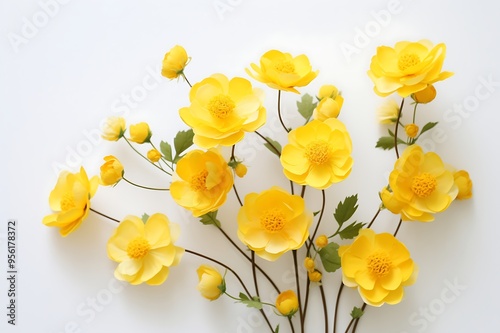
[0,0,500,333]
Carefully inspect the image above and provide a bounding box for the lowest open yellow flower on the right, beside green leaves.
[338,229,417,306]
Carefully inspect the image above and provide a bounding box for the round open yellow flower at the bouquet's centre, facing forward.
[238,186,313,261]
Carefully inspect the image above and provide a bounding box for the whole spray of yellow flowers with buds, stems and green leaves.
[43,40,472,333]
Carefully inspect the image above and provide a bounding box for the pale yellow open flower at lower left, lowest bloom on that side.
[107,213,184,285]
